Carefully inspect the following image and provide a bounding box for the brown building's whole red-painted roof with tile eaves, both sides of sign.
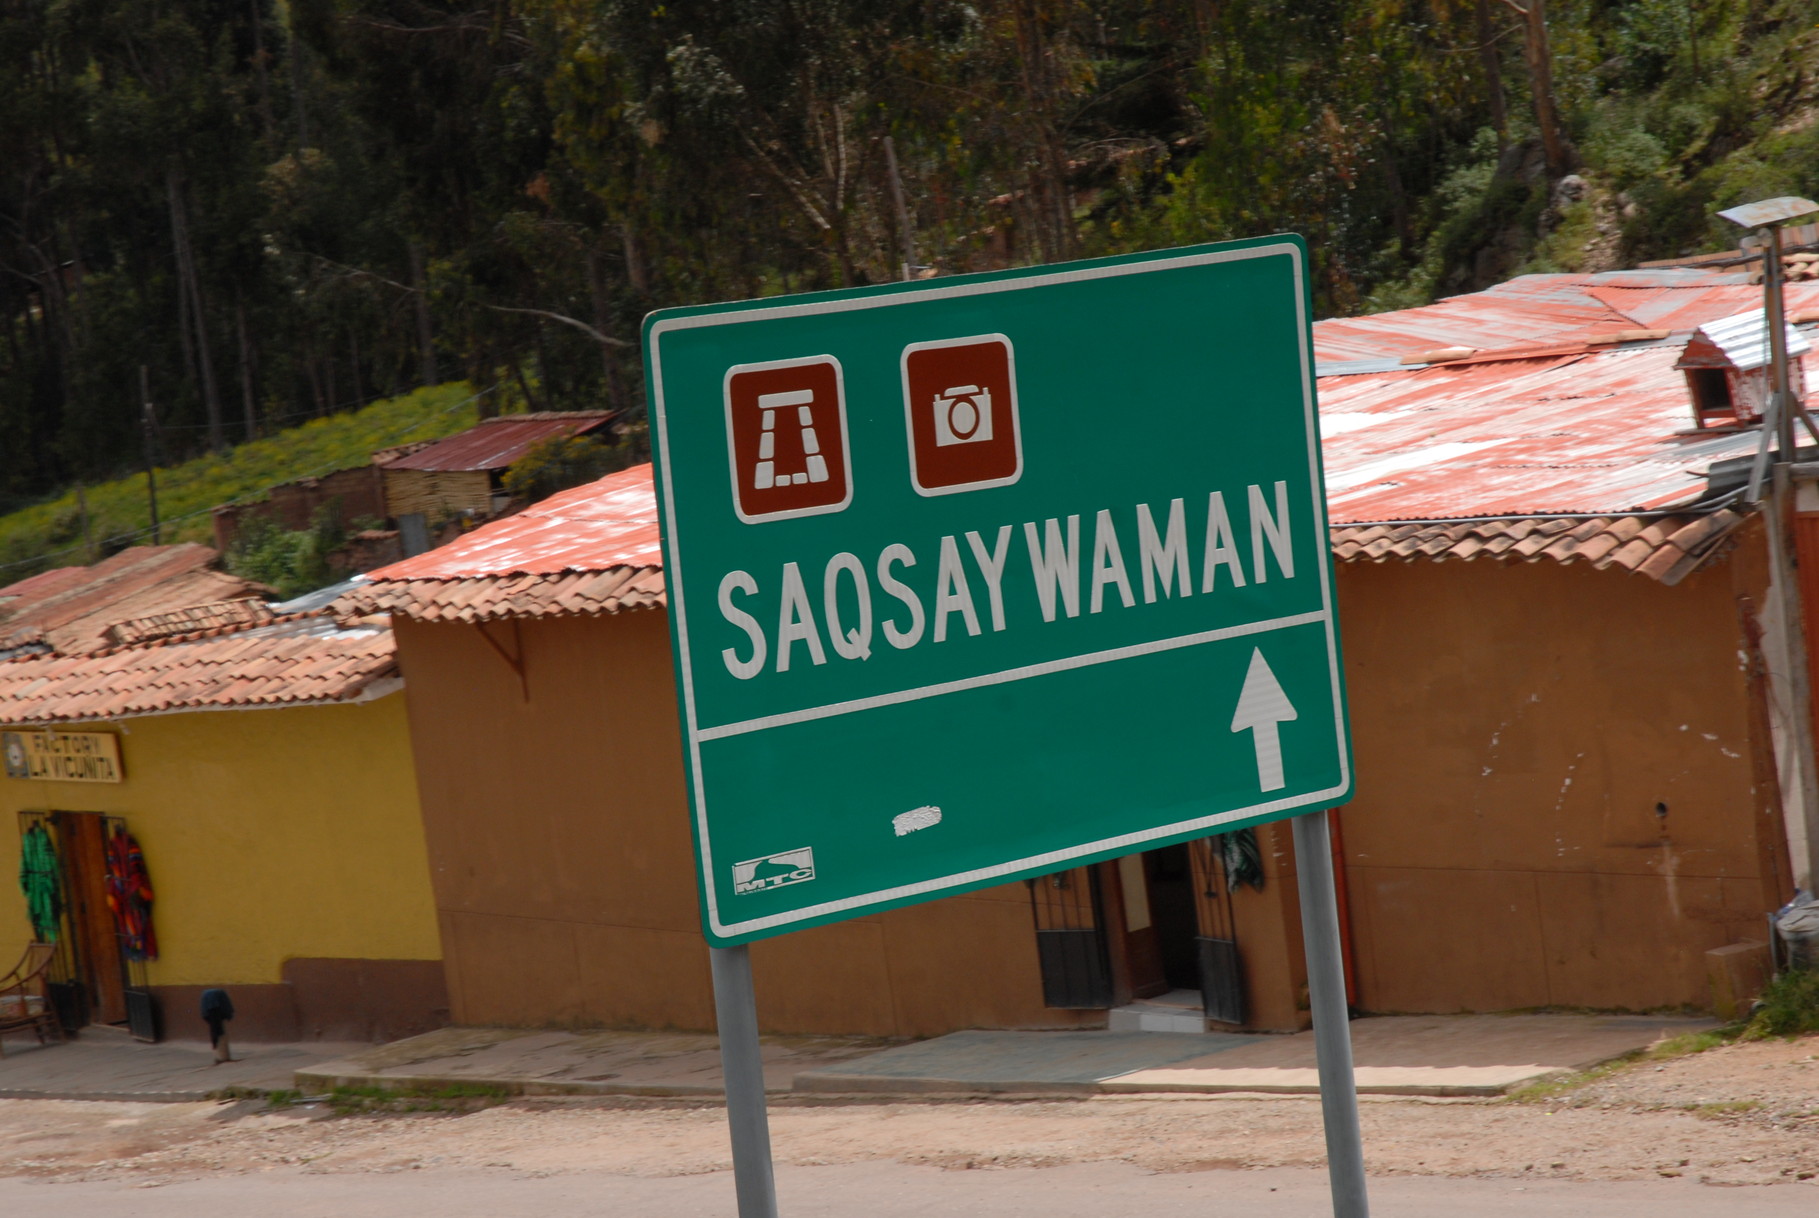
[351,269,1819,620]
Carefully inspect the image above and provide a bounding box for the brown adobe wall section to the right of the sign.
[1339,529,1790,1011]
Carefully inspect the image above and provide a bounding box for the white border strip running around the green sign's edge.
[649,242,1352,938]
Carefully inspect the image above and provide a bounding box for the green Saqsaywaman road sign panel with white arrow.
[644,236,1352,945]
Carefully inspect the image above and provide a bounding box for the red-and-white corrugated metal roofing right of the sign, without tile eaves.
[1313,269,1819,524]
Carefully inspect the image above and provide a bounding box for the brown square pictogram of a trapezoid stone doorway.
[726,354,853,524]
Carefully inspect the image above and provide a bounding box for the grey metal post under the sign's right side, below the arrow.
[1293,811,1370,1218]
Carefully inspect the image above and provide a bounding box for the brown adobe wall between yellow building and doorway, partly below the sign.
[397,613,1104,1036]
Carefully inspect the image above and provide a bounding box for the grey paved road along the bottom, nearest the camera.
[0,1162,1819,1218]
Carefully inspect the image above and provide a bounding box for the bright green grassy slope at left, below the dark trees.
[0,384,478,584]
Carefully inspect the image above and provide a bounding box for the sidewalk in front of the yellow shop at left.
[0,1029,366,1102]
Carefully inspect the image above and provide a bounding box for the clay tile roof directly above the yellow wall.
[0,614,398,724]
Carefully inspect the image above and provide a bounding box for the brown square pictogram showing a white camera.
[904,334,1022,494]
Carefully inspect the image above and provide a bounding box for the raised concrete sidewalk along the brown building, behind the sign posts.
[296,1014,1713,1096]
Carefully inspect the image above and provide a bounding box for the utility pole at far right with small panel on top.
[1717,196,1819,891]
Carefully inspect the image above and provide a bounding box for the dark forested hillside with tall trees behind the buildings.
[10,0,1819,507]
